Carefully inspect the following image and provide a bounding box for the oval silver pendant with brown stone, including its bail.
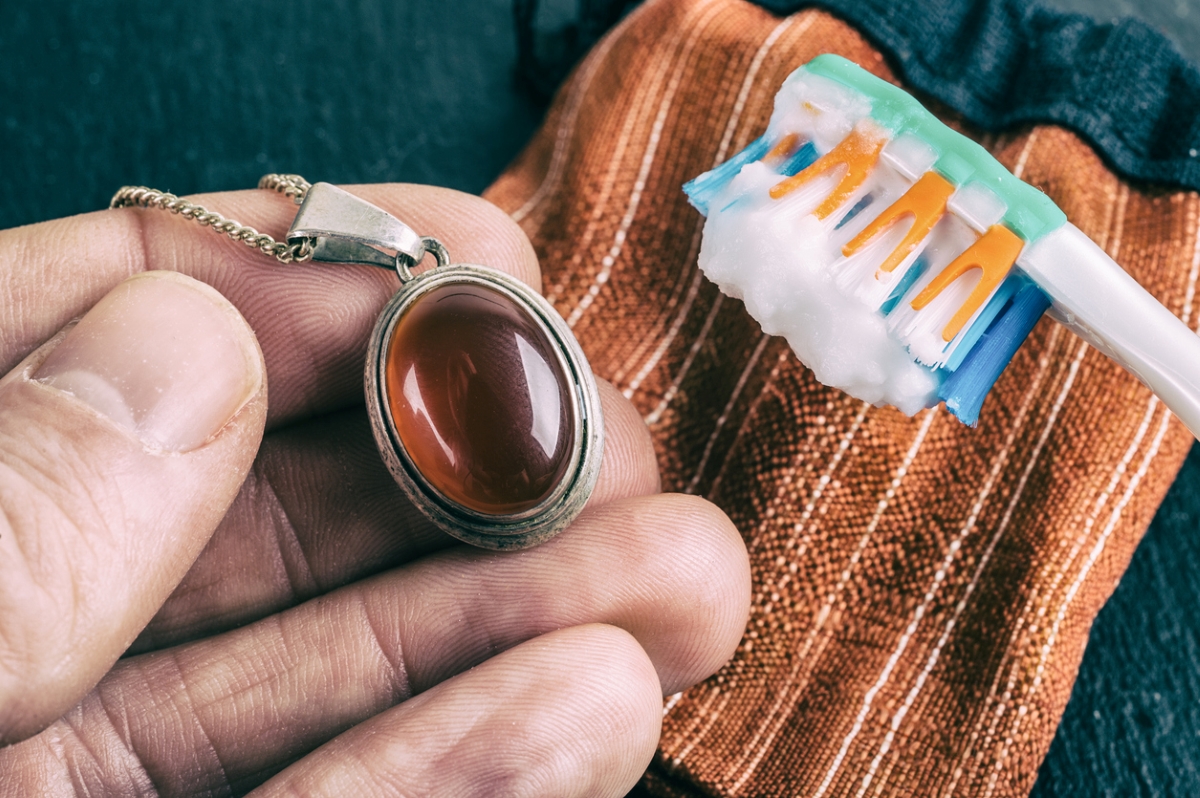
[288,182,604,550]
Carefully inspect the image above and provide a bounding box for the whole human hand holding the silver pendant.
[0,186,749,796]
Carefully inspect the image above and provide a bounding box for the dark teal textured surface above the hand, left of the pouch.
[0,0,552,228]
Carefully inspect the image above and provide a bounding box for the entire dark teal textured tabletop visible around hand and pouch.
[0,0,1200,798]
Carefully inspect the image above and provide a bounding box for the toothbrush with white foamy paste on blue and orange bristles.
[684,55,1200,436]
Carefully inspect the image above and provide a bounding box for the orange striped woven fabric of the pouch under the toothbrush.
[487,0,1200,797]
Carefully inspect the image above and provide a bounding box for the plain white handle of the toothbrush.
[1016,222,1200,438]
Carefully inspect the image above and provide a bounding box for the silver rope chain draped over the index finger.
[108,174,313,263]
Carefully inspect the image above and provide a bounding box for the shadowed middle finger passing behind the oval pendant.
[131,380,659,653]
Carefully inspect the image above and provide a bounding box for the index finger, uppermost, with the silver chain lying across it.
[0,184,541,426]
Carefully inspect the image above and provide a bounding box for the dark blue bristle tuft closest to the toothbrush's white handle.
[937,281,1050,426]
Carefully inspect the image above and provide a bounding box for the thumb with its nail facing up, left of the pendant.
[0,271,266,744]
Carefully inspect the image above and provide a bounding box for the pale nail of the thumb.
[34,271,263,451]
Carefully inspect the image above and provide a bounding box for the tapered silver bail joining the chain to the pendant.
[288,182,425,269]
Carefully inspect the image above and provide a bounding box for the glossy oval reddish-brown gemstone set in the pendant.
[386,283,575,515]
